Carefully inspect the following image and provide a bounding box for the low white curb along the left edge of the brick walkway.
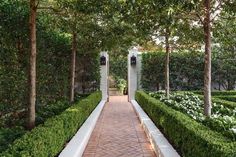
[59,100,106,157]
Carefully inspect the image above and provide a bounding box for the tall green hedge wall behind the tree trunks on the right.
[141,51,236,91]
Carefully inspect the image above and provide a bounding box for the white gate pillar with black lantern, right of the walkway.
[128,48,138,101]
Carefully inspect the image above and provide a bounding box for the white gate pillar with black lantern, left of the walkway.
[100,52,109,101]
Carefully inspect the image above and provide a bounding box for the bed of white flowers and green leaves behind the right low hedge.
[149,92,236,140]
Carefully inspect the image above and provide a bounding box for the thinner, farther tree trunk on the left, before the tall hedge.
[70,32,77,103]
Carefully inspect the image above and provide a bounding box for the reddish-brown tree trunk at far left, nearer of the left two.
[27,0,37,129]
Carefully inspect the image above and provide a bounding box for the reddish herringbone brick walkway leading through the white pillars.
[83,96,155,157]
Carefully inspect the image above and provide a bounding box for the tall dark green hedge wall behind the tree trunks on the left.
[0,0,100,121]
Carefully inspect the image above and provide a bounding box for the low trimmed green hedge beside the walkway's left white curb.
[0,92,101,157]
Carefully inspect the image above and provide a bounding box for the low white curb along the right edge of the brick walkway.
[131,100,180,157]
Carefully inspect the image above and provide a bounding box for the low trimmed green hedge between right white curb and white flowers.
[136,91,236,157]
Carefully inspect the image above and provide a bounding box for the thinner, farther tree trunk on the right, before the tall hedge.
[165,29,170,99]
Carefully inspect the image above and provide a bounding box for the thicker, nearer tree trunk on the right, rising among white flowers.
[204,0,211,116]
